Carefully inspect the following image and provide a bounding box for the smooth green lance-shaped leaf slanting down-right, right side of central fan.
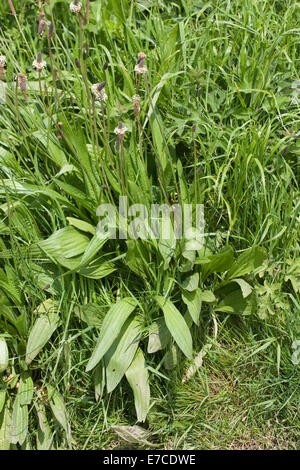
[155,295,193,359]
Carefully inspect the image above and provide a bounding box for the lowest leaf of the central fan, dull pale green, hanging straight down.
[126,349,150,421]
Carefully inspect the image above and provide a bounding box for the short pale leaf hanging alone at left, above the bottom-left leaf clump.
[26,312,59,364]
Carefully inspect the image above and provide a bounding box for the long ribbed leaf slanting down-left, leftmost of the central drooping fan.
[86,297,137,371]
